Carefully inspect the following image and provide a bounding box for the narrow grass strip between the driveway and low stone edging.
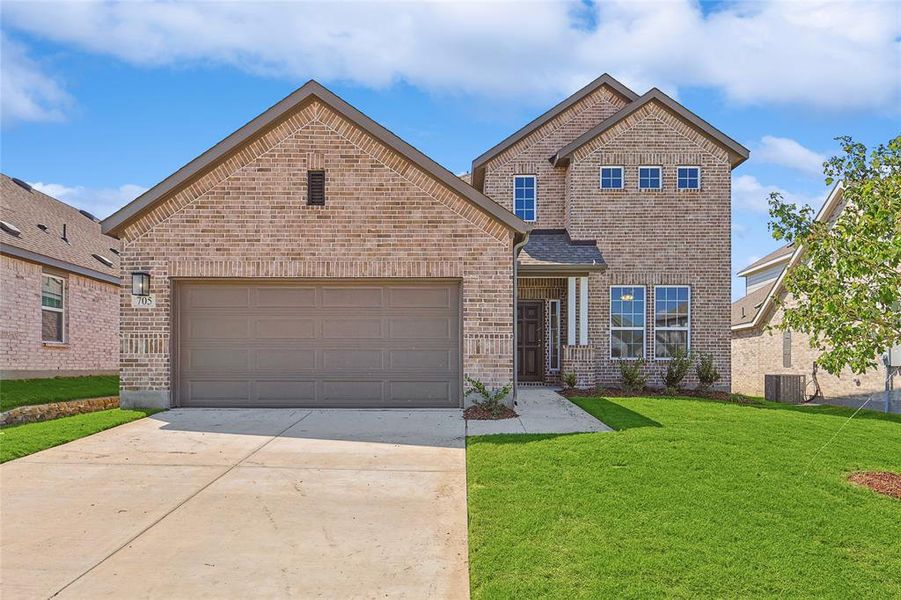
[0,408,159,463]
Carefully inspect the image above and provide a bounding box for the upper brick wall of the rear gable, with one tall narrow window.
[483,86,625,229]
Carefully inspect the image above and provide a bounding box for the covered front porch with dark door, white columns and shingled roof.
[516,230,606,387]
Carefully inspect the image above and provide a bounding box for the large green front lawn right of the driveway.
[467,398,901,599]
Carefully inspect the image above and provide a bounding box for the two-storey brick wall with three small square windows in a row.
[567,103,731,390]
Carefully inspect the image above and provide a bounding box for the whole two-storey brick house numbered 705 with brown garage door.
[103,75,747,407]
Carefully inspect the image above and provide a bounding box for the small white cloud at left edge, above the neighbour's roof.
[0,33,72,124]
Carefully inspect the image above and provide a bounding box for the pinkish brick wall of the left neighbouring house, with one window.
[0,256,119,376]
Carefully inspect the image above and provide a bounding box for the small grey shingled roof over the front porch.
[519,229,606,271]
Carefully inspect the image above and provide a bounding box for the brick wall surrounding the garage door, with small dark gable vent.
[120,102,513,404]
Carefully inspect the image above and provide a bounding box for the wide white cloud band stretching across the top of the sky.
[4,0,901,111]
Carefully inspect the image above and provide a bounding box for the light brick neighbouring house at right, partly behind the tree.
[732,184,901,409]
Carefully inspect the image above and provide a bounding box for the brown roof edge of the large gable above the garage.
[103,80,529,239]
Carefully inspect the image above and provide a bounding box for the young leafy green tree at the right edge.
[770,135,901,375]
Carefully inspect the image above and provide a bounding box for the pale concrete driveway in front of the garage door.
[0,409,469,600]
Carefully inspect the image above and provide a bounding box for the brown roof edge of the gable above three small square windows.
[550,88,749,169]
